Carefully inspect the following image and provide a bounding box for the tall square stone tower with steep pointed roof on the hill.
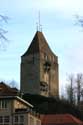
[21,31,59,97]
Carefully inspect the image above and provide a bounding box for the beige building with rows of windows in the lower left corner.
[0,96,41,125]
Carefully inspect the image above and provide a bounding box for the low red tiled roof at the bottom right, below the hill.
[41,114,83,125]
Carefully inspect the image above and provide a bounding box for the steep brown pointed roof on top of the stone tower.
[23,31,52,56]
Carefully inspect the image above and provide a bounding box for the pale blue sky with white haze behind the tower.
[0,0,83,92]
